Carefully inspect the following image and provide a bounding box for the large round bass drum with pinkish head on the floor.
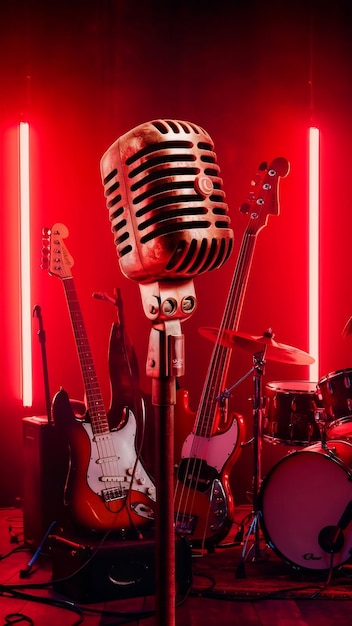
[259,440,352,570]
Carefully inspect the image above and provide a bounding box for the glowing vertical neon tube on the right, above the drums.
[308,127,319,382]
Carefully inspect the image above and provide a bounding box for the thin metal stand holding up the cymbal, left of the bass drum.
[236,346,266,578]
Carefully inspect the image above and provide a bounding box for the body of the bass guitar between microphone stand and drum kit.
[174,390,244,548]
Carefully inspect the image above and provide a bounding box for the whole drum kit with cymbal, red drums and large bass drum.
[200,318,352,571]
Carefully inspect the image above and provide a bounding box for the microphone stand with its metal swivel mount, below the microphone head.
[139,280,196,626]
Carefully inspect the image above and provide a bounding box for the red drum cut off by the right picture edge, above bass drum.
[318,369,352,438]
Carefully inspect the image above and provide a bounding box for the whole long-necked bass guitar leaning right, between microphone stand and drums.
[174,158,289,547]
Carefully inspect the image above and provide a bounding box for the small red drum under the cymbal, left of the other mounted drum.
[263,381,320,446]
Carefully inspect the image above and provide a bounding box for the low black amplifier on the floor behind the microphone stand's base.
[49,535,192,603]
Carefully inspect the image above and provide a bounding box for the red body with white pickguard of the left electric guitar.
[53,389,156,534]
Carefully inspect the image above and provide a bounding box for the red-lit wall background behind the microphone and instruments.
[0,0,352,504]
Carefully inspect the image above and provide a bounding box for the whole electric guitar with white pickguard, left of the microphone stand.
[42,224,156,532]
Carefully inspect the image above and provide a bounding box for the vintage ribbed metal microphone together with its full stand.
[101,119,233,626]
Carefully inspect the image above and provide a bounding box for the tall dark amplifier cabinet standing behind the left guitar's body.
[22,416,68,549]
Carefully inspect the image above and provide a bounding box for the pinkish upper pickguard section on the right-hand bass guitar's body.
[181,420,238,473]
